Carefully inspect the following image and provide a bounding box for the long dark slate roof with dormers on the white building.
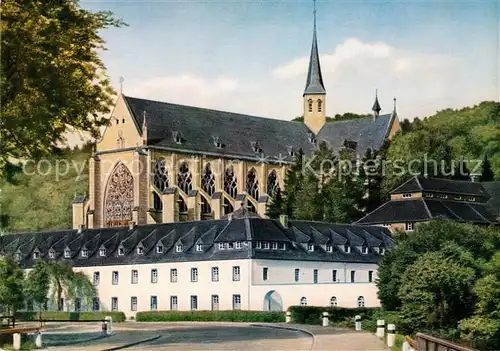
[0,218,394,268]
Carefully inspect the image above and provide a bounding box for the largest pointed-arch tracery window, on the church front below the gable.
[104,163,134,227]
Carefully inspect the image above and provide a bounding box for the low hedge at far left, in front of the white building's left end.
[16,312,125,322]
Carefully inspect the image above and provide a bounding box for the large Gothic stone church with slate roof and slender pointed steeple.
[73,9,399,229]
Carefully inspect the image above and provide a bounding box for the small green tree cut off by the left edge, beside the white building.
[0,256,24,315]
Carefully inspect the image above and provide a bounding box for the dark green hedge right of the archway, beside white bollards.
[288,306,381,325]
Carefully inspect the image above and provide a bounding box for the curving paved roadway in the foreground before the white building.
[47,322,387,351]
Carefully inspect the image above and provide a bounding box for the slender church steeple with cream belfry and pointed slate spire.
[302,0,326,134]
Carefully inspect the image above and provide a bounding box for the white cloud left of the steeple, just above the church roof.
[124,74,238,108]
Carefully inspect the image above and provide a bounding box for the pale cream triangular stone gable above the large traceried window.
[96,94,143,151]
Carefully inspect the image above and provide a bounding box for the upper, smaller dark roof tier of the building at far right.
[391,176,489,197]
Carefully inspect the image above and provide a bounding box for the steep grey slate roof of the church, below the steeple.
[123,96,394,162]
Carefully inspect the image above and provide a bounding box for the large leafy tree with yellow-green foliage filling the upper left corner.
[0,0,124,169]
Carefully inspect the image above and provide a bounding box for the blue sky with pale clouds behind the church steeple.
[81,0,500,120]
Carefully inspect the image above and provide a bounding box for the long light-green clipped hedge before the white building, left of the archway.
[135,310,285,323]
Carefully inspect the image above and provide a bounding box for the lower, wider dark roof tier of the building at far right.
[356,198,500,224]
